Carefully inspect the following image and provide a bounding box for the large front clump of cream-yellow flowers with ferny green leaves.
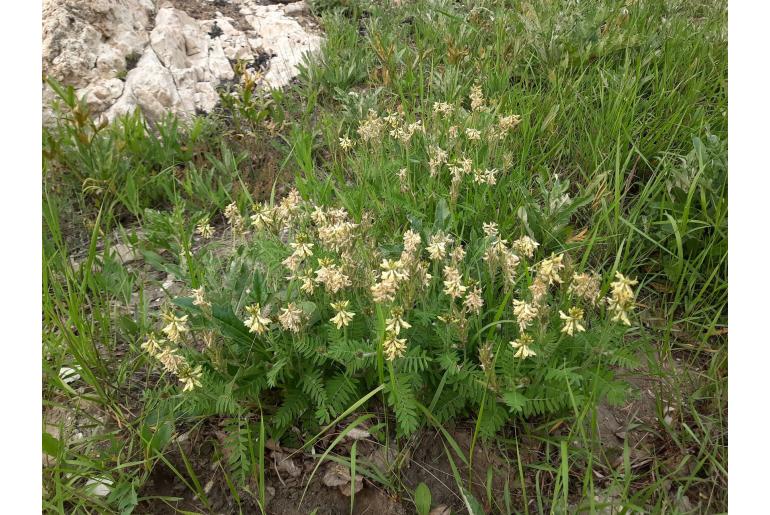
[143,194,636,435]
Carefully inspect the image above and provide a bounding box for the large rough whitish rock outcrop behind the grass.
[43,0,322,123]
